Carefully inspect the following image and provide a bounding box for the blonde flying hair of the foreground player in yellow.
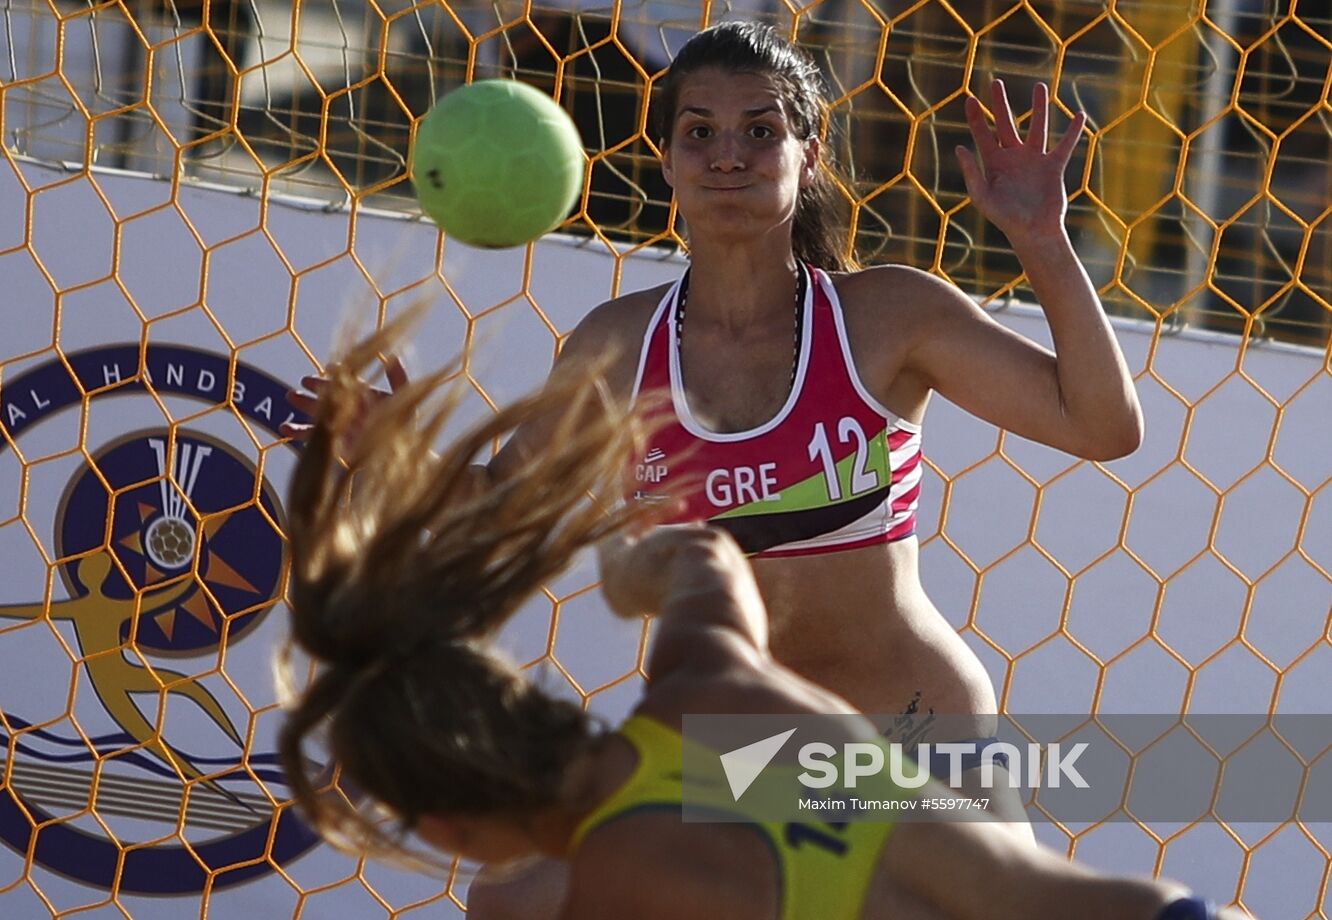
[278,317,642,853]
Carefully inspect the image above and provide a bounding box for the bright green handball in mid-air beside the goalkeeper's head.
[410,80,585,248]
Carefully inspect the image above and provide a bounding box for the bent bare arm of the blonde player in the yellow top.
[598,525,769,680]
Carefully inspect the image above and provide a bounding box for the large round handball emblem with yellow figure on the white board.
[0,345,317,895]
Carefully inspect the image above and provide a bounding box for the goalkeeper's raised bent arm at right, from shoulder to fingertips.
[866,81,1143,459]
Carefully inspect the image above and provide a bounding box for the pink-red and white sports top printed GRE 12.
[634,266,920,557]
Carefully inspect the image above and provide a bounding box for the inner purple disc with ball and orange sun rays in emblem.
[57,429,284,655]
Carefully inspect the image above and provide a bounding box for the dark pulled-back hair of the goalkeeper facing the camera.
[653,21,859,272]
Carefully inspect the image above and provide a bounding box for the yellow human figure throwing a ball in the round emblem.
[0,550,245,798]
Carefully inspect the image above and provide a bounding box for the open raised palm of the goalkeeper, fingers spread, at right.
[956,80,1087,244]
